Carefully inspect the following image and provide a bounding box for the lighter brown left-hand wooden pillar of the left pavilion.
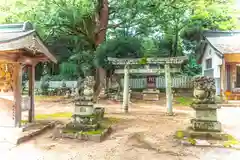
[14,63,22,127]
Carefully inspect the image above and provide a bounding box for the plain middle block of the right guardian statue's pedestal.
[195,110,217,121]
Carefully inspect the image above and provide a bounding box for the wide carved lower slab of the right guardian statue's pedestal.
[191,119,222,132]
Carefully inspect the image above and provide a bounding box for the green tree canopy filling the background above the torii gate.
[0,0,237,77]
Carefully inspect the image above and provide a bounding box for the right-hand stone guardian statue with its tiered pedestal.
[191,76,221,132]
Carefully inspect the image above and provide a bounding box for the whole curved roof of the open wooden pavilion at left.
[0,22,57,63]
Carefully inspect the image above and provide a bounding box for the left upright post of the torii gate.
[123,65,129,113]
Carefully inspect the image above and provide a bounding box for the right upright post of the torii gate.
[165,64,173,115]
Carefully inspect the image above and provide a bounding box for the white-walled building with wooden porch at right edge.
[198,31,240,100]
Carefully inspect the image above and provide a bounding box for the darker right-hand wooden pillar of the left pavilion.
[28,65,35,123]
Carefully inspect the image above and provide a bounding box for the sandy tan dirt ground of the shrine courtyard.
[1,100,240,160]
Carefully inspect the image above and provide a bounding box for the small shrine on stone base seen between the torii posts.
[142,76,160,101]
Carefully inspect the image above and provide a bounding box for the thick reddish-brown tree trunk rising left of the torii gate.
[94,0,109,98]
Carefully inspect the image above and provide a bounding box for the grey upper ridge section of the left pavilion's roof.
[0,22,35,43]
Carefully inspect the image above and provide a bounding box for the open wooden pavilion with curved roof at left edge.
[0,22,57,127]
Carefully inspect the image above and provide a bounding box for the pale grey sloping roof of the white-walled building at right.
[204,31,240,54]
